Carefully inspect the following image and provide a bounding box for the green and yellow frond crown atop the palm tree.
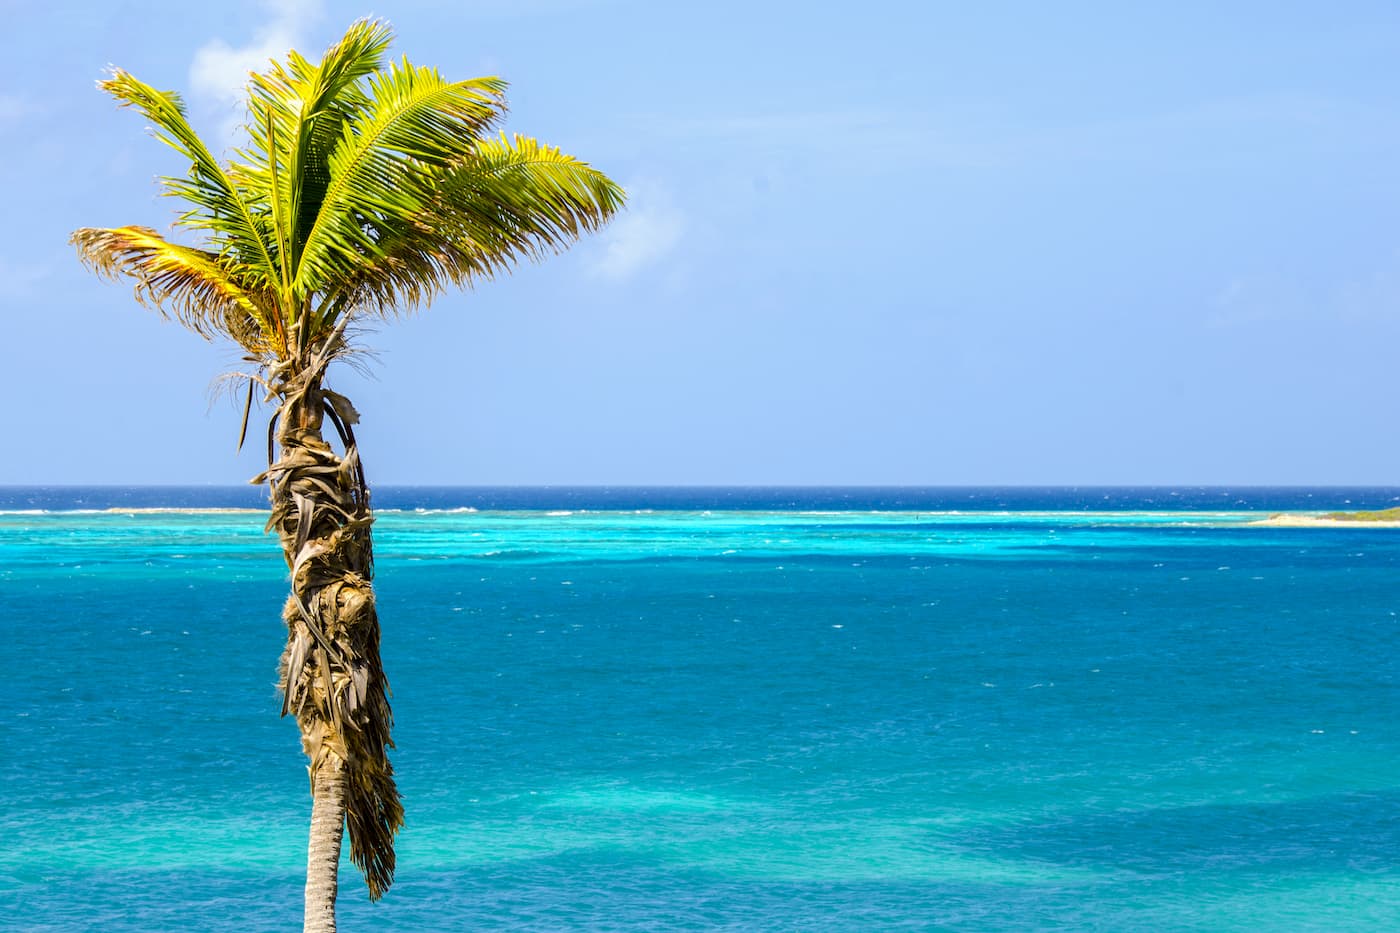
[73,21,623,366]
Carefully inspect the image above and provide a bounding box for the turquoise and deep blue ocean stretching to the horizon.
[0,488,1400,933]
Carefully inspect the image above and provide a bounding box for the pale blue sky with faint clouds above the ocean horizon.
[0,0,1400,485]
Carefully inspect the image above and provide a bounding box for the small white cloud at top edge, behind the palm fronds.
[189,0,322,143]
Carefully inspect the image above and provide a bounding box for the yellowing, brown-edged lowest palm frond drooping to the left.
[71,227,277,348]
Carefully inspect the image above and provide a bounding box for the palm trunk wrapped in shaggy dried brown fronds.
[266,375,403,933]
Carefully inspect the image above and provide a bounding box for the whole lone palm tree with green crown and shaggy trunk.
[73,20,623,932]
